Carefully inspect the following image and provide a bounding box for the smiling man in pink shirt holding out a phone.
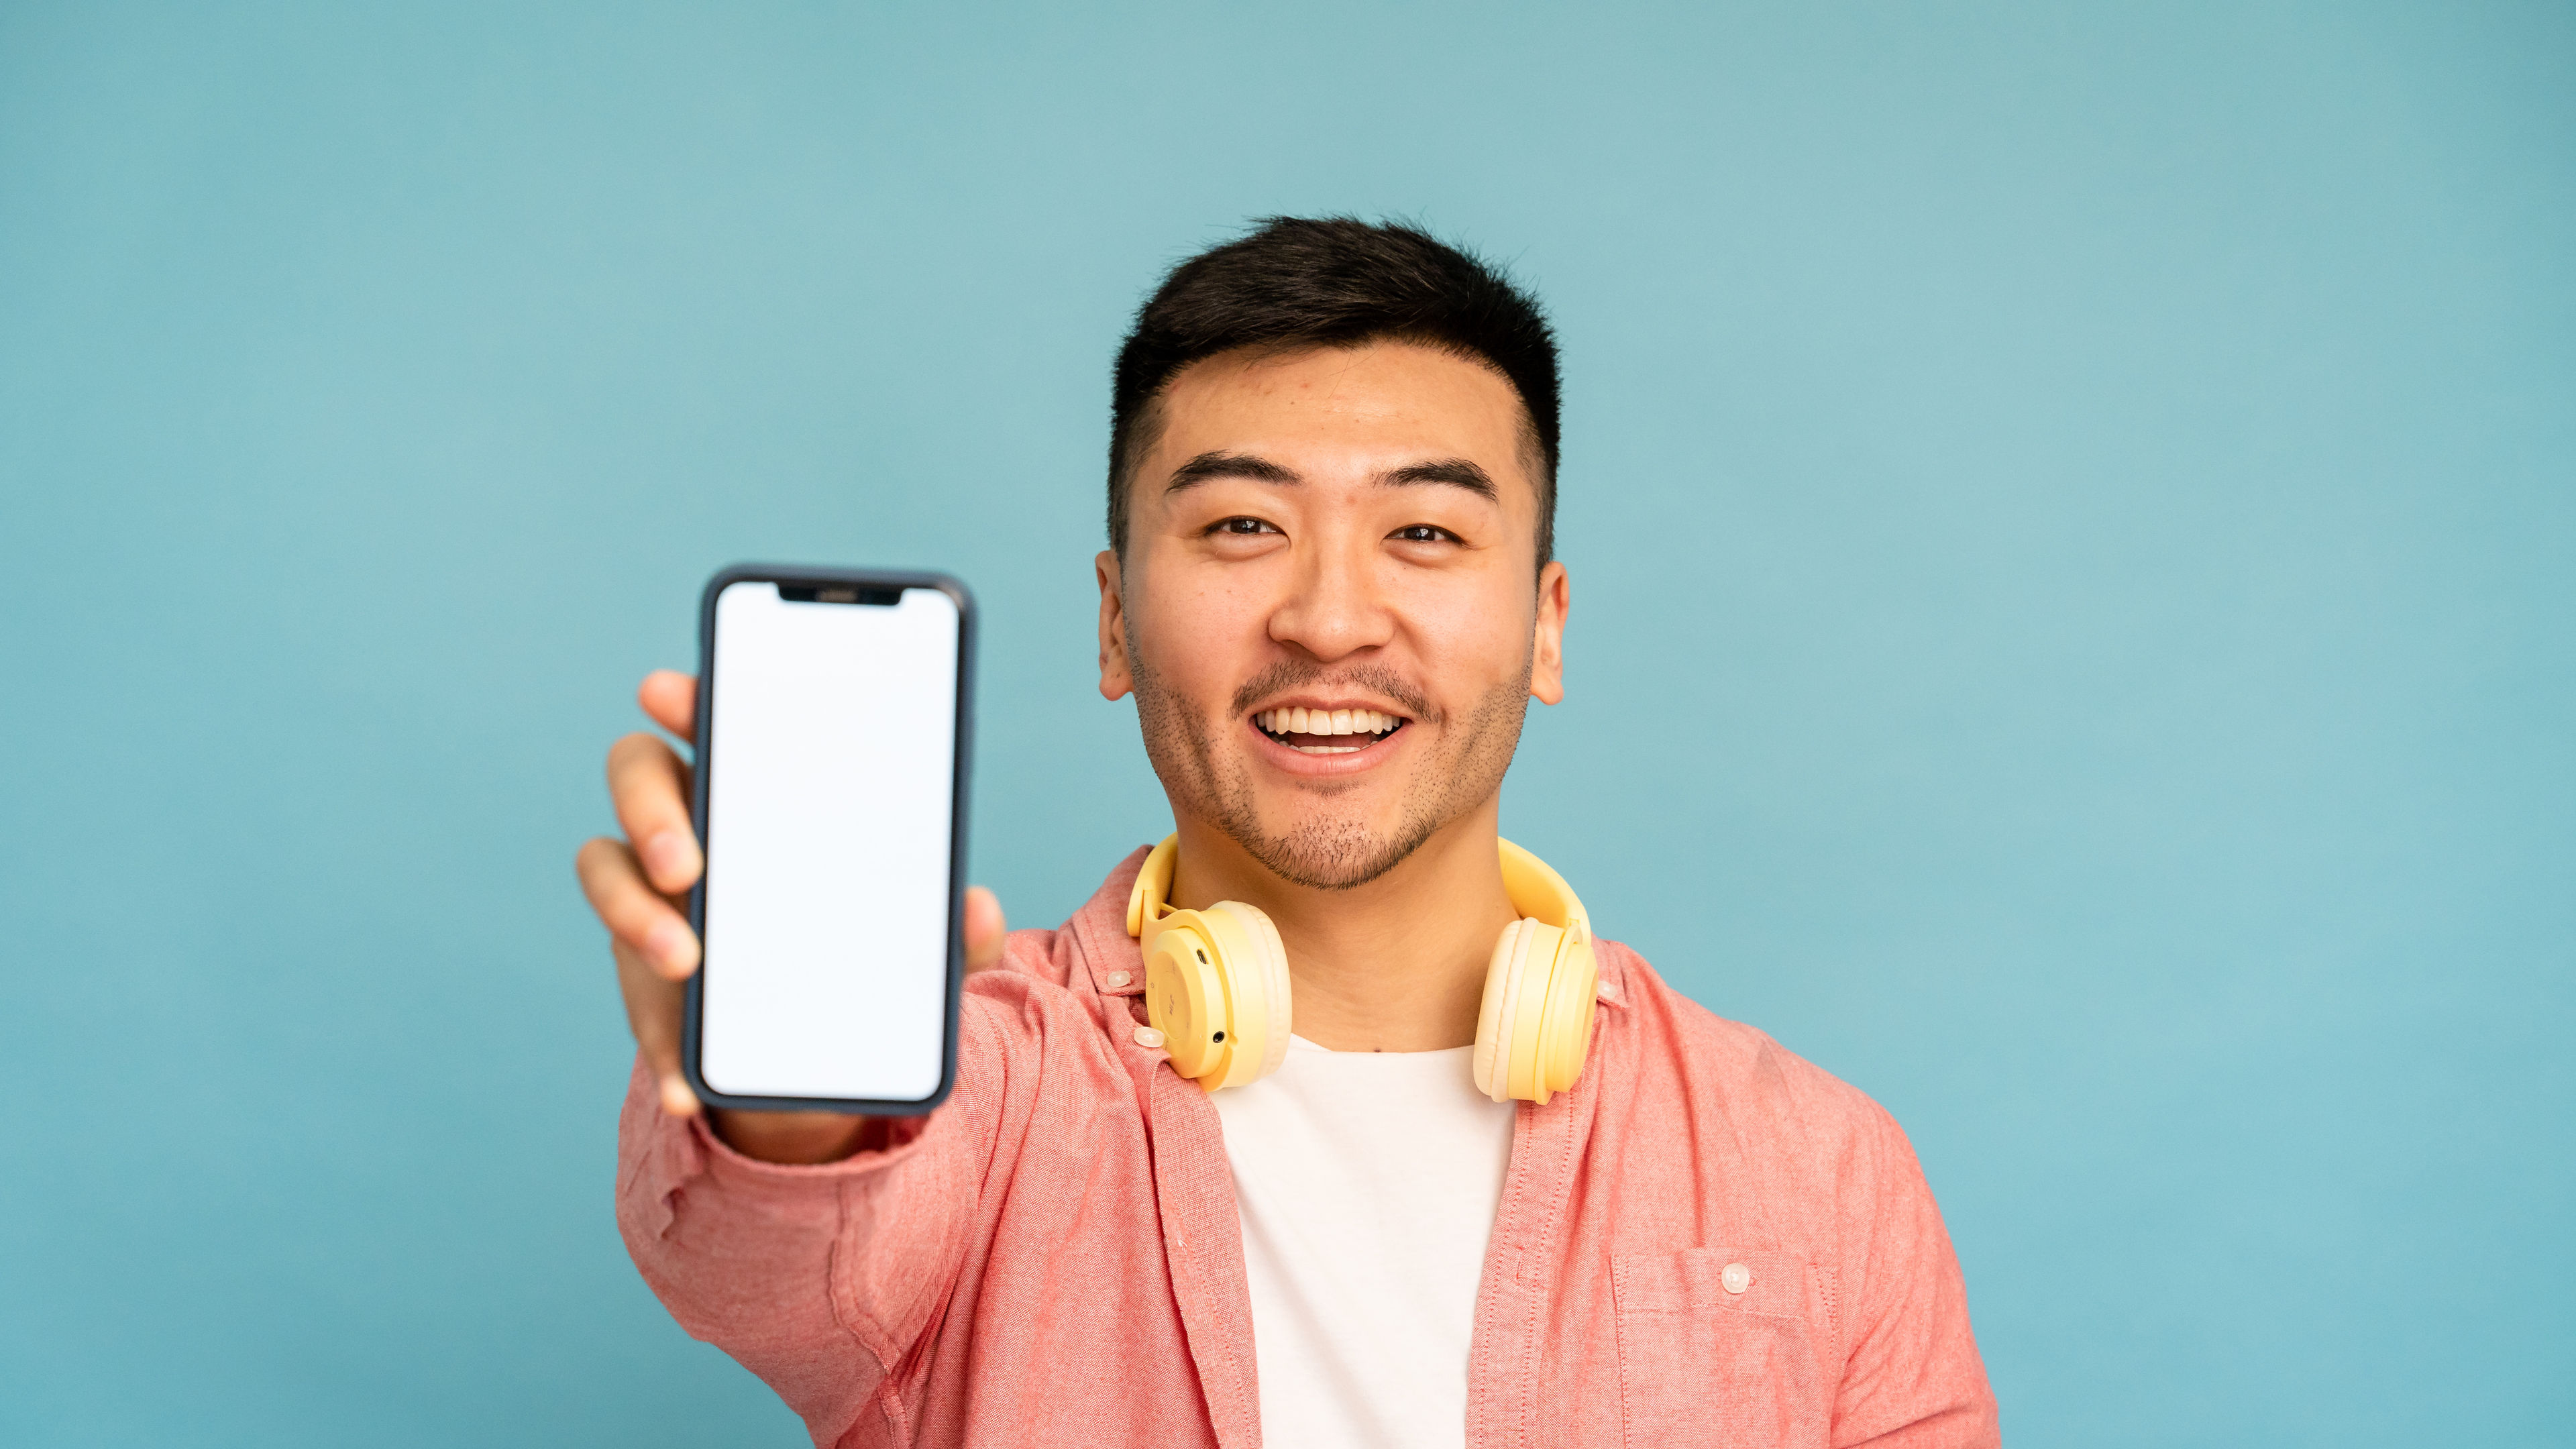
[580,219,1996,1449]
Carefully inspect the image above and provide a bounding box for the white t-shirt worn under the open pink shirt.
[1211,1036,1515,1449]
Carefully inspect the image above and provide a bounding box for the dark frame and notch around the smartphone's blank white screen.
[680,565,976,1116]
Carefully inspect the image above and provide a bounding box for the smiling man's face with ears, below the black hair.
[1100,343,1566,887]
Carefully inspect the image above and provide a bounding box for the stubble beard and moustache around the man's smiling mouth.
[1128,632,1530,890]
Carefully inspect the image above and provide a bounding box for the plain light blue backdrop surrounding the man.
[0,3,2576,1444]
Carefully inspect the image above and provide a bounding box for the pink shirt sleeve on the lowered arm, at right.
[1834,1104,2002,1449]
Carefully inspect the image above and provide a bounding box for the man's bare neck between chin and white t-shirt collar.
[1172,799,1517,1052]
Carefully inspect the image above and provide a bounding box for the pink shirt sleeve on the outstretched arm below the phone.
[619,993,1007,1444]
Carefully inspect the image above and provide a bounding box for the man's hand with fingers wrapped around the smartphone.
[580,570,1002,1163]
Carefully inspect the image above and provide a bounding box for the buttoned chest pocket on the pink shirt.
[1610,1248,1839,1449]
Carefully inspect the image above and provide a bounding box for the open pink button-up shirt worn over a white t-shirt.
[619,851,1999,1449]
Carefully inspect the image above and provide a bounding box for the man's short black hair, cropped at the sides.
[1108,217,1556,568]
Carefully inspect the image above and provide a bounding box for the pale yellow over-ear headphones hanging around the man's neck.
[1128,835,1600,1104]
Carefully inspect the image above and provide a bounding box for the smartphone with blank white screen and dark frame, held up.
[680,565,974,1116]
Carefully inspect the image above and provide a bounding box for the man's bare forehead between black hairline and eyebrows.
[1144,340,1533,487]
